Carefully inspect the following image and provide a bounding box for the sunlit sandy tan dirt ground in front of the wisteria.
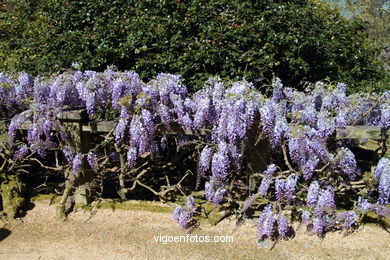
[0,202,390,260]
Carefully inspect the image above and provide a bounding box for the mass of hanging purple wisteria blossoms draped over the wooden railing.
[0,68,390,239]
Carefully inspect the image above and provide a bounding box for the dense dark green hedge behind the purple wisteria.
[0,0,384,91]
